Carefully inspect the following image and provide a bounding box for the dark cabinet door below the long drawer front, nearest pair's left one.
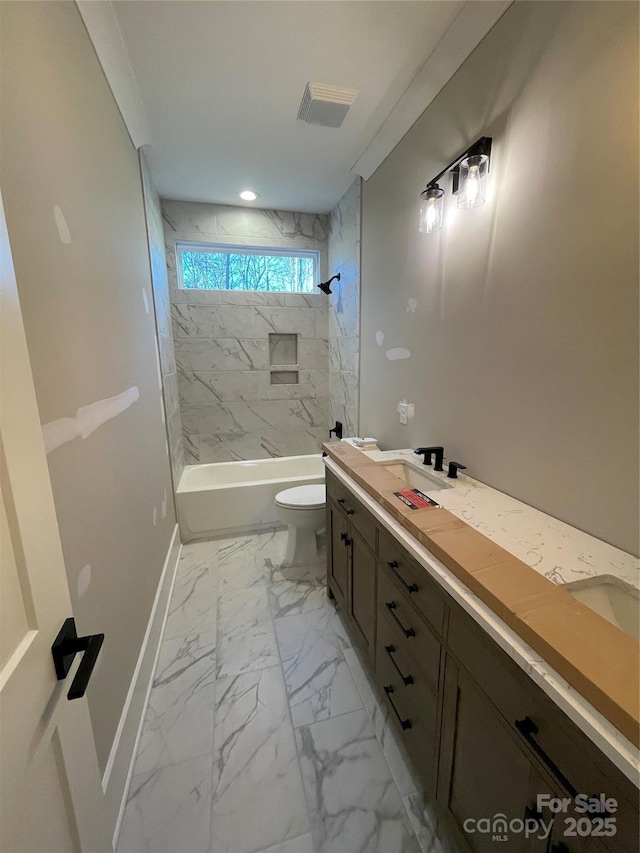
[437,658,535,853]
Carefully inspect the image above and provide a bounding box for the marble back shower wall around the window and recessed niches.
[162,200,330,465]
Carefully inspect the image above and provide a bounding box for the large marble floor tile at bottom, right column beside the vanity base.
[296,709,420,853]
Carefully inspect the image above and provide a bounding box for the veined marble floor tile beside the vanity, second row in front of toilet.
[274,603,362,726]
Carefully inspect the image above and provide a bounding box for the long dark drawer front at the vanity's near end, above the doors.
[448,612,638,850]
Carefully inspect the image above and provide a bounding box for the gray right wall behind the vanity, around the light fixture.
[360,2,638,552]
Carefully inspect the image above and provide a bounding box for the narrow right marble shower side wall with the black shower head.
[329,178,361,436]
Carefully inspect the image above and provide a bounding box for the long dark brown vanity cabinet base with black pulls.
[327,471,640,853]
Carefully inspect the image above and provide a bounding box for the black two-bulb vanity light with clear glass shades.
[419,136,491,234]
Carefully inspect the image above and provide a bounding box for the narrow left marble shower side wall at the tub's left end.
[140,151,184,489]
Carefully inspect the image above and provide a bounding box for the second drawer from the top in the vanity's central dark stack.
[378,565,440,690]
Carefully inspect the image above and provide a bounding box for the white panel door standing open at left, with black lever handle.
[0,197,112,853]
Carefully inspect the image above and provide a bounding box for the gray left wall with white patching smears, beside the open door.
[0,3,175,769]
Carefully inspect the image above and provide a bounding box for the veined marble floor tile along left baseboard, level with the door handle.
[134,634,216,774]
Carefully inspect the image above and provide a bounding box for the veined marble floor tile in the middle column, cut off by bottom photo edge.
[211,666,309,853]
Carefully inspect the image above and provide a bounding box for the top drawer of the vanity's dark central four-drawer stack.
[378,530,445,634]
